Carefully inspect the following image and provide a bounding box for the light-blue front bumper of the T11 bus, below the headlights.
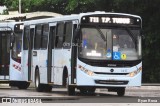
[77,70,142,87]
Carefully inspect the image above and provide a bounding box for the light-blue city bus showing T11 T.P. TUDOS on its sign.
[21,12,142,96]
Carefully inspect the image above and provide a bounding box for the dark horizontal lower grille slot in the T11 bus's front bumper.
[95,80,128,85]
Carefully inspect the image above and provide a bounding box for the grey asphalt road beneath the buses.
[0,85,160,106]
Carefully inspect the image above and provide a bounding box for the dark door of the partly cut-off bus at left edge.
[0,32,10,80]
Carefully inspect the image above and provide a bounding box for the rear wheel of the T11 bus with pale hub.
[34,68,43,92]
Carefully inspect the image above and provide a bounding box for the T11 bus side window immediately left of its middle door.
[41,24,49,49]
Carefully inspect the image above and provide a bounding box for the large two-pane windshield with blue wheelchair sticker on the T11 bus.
[79,27,141,61]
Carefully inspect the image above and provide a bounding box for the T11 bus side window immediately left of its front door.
[63,22,72,49]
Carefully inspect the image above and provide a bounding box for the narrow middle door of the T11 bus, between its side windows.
[47,23,56,83]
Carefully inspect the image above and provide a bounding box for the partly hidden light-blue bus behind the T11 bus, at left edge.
[0,21,29,89]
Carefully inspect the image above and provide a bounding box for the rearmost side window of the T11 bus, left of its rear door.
[23,26,29,50]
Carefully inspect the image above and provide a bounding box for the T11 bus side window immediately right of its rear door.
[34,25,42,49]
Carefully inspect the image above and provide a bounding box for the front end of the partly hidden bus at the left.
[9,22,30,89]
